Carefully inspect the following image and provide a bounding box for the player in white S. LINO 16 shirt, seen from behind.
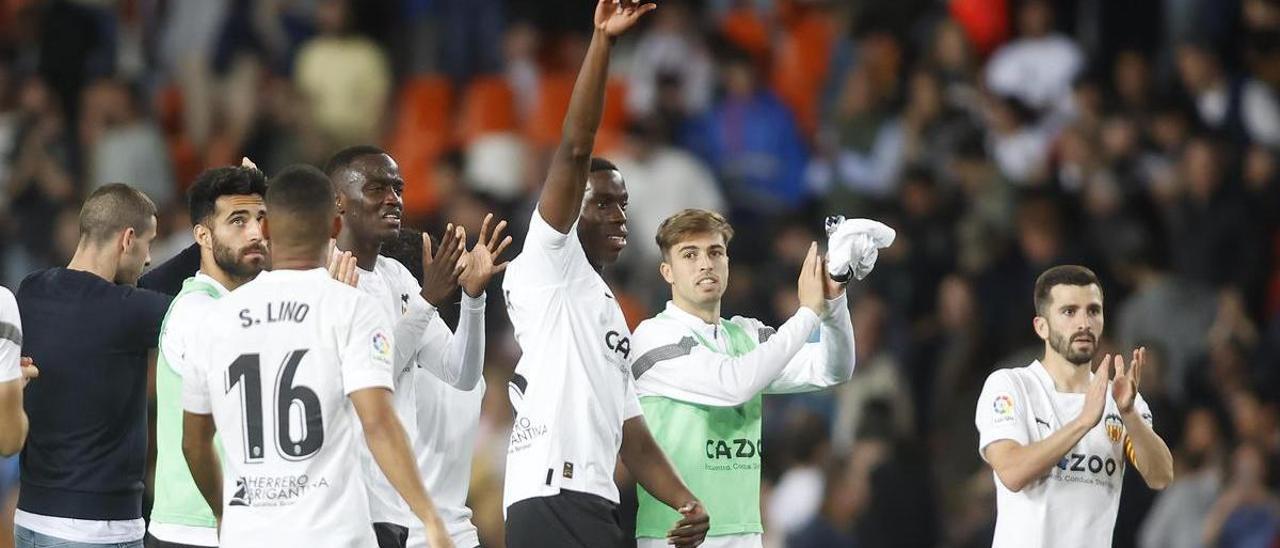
[183,166,452,548]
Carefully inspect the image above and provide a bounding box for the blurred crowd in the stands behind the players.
[0,0,1280,548]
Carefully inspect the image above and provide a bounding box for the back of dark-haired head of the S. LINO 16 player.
[266,164,338,246]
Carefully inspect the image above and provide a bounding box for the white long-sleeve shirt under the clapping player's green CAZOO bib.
[631,294,854,407]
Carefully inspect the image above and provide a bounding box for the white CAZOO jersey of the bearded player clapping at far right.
[974,360,1151,548]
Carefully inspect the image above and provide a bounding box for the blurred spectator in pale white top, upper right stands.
[987,0,1084,110]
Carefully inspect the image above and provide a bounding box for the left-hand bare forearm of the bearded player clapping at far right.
[983,420,1093,493]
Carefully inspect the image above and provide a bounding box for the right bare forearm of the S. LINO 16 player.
[351,388,443,528]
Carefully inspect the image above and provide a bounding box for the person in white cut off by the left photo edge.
[0,287,38,457]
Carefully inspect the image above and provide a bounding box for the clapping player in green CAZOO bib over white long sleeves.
[631,209,854,548]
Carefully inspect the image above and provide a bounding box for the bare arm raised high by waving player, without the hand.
[538,29,613,234]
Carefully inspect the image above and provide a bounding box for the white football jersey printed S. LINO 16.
[183,269,394,548]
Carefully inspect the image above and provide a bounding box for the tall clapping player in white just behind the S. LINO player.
[325,145,511,548]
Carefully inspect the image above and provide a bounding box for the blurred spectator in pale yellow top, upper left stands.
[294,0,392,149]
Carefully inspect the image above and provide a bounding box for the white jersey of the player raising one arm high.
[503,209,641,506]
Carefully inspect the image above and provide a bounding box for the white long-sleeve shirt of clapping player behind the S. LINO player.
[357,256,485,530]
